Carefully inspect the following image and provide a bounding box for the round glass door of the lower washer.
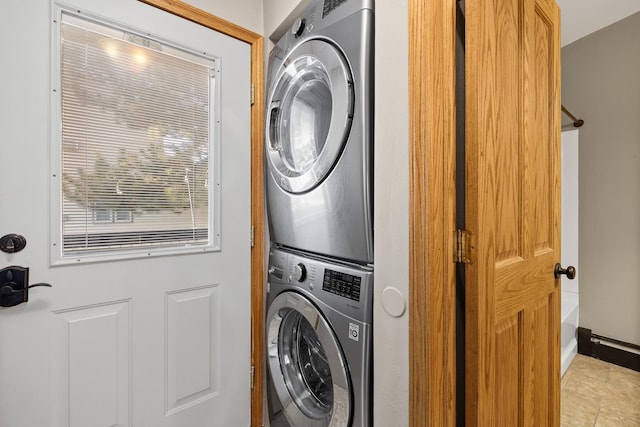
[267,292,352,427]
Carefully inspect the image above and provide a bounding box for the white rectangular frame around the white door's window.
[49,3,221,266]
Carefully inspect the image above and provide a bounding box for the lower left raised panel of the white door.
[52,300,132,427]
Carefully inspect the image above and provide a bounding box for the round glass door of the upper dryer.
[265,39,354,193]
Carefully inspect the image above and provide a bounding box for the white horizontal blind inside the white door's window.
[60,13,214,256]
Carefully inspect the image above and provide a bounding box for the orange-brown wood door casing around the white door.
[139,0,265,426]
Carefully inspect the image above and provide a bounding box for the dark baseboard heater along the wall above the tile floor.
[578,327,640,372]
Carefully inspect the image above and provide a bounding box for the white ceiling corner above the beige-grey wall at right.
[556,0,640,46]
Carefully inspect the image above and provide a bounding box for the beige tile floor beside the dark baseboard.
[560,354,640,427]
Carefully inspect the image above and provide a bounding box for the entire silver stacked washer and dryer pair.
[265,0,374,427]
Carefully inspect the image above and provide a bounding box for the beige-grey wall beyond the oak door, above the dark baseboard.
[562,13,640,344]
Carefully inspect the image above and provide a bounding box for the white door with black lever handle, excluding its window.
[0,0,251,427]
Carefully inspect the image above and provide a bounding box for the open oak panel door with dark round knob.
[466,0,560,426]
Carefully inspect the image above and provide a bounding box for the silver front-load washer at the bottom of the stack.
[266,248,373,427]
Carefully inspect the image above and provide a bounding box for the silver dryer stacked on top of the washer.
[265,0,373,264]
